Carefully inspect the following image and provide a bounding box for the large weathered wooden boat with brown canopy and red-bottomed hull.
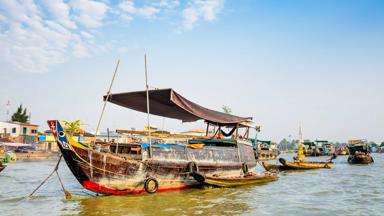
[48,89,256,195]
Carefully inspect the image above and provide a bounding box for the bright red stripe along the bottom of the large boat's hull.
[82,181,191,195]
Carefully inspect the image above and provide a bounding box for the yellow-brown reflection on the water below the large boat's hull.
[78,187,251,215]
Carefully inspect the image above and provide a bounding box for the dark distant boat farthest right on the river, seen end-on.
[347,140,374,164]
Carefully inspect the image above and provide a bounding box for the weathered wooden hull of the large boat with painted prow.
[48,120,256,195]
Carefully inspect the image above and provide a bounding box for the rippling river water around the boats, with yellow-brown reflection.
[0,154,384,216]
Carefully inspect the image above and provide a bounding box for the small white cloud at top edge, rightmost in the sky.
[182,0,224,30]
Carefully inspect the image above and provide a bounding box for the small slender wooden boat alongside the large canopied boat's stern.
[195,172,279,187]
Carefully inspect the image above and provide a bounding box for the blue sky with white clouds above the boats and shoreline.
[0,0,384,142]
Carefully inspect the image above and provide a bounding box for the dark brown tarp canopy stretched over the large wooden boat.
[104,89,252,126]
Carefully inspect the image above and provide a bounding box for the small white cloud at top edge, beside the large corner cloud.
[71,0,108,28]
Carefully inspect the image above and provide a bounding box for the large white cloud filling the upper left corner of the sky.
[0,0,102,73]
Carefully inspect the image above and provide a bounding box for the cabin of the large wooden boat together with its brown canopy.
[100,89,258,166]
